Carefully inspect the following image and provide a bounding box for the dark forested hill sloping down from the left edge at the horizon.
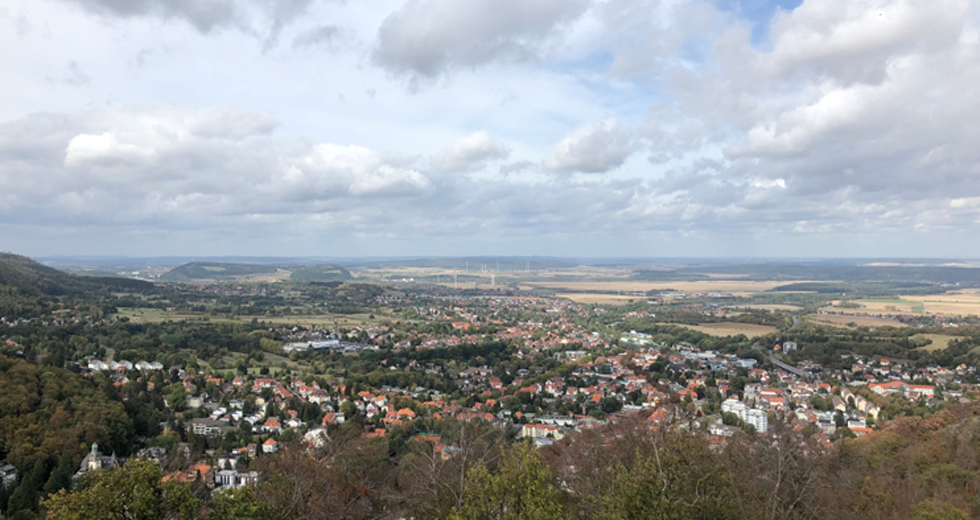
[0,253,153,296]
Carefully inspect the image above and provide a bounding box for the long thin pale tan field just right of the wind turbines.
[524,280,800,295]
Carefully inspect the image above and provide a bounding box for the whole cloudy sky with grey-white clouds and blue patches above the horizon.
[0,0,980,258]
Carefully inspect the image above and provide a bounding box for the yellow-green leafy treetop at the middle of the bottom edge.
[450,444,563,520]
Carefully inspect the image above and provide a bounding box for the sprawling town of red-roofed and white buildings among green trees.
[4,284,978,504]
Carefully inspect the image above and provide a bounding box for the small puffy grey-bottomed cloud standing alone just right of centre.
[545,119,636,173]
